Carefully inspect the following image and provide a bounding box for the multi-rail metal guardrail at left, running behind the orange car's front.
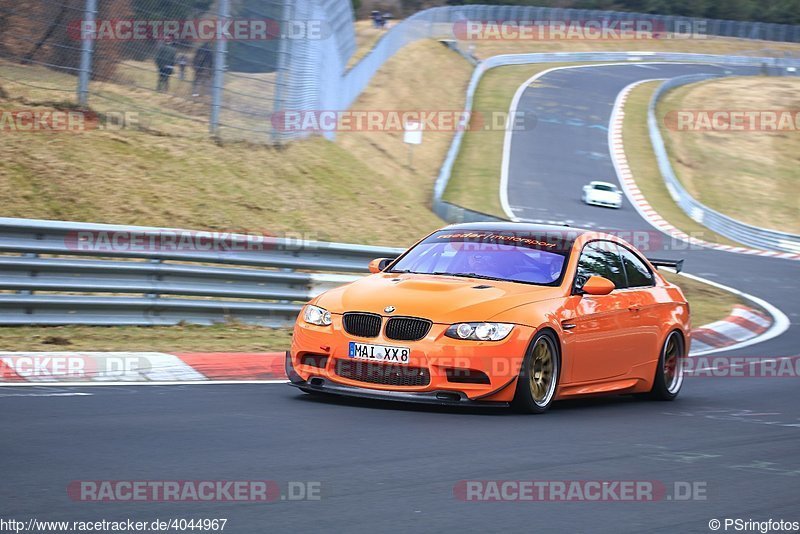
[0,218,402,326]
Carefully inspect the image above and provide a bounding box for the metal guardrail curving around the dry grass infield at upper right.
[647,74,800,254]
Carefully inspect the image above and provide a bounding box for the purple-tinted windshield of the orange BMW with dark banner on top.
[389,230,571,285]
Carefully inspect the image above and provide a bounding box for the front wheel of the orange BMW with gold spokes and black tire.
[512,331,561,414]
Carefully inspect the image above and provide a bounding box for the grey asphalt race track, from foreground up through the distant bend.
[0,65,800,533]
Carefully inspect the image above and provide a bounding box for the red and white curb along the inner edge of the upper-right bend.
[608,78,800,260]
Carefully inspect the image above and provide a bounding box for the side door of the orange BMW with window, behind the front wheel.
[562,241,634,382]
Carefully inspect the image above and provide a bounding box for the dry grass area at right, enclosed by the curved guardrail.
[657,77,800,234]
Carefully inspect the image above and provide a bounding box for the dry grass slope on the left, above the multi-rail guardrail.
[0,41,472,246]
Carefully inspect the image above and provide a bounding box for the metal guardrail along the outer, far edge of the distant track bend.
[432,52,800,225]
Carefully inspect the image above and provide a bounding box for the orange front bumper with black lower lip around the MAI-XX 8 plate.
[286,317,534,406]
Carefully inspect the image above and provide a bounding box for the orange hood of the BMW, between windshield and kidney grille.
[316,273,563,324]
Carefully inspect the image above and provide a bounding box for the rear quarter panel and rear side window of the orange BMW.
[619,246,661,372]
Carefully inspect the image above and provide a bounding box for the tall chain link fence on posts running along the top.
[0,0,800,143]
